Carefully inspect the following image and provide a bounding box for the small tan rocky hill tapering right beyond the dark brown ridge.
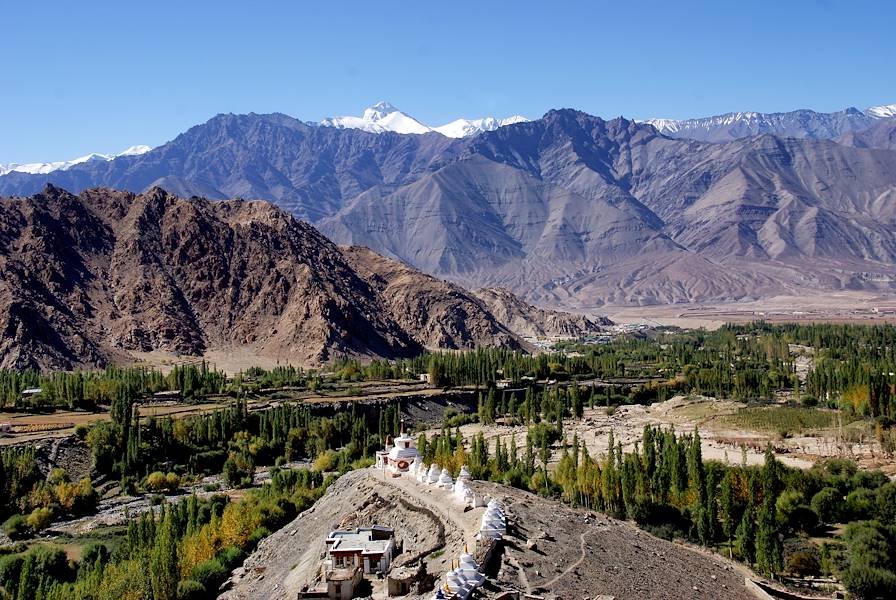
[473,288,613,338]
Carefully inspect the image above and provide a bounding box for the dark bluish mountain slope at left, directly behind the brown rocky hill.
[0,114,462,222]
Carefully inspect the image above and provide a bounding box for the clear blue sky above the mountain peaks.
[0,0,896,163]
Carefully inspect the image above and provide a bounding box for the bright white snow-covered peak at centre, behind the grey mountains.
[319,102,529,138]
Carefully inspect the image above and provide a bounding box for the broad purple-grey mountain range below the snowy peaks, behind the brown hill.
[0,102,896,308]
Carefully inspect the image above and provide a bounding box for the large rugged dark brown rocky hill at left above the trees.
[0,186,521,368]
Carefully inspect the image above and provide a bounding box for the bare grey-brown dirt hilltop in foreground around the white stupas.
[220,469,755,600]
